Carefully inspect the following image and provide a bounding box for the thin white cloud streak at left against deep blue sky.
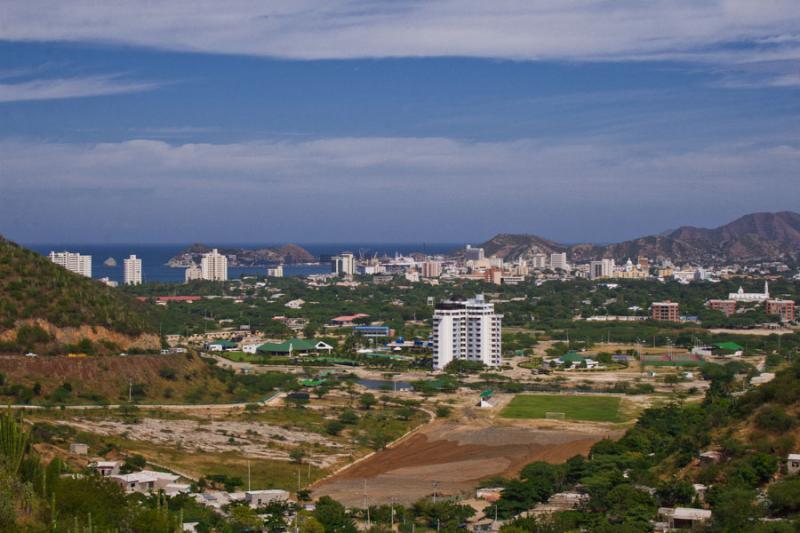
[0,75,160,103]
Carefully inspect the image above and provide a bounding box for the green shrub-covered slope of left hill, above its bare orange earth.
[0,237,158,336]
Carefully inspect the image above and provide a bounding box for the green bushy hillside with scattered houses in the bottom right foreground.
[492,363,800,533]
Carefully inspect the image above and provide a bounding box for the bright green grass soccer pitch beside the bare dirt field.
[500,394,626,422]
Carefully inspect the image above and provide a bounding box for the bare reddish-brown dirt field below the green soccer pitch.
[314,420,619,507]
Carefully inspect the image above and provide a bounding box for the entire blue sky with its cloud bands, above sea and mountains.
[0,0,800,242]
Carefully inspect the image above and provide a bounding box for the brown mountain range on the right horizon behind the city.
[481,211,800,263]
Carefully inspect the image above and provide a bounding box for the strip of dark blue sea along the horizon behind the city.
[24,243,464,283]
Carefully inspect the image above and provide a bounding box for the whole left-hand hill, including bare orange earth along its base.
[0,237,160,352]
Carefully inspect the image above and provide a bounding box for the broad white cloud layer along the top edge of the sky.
[0,0,800,60]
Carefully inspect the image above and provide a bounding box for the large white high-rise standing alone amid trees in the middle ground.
[433,295,503,370]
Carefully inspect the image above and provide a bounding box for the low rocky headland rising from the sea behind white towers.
[167,244,317,267]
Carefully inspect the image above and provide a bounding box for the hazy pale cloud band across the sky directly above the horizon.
[0,138,800,242]
